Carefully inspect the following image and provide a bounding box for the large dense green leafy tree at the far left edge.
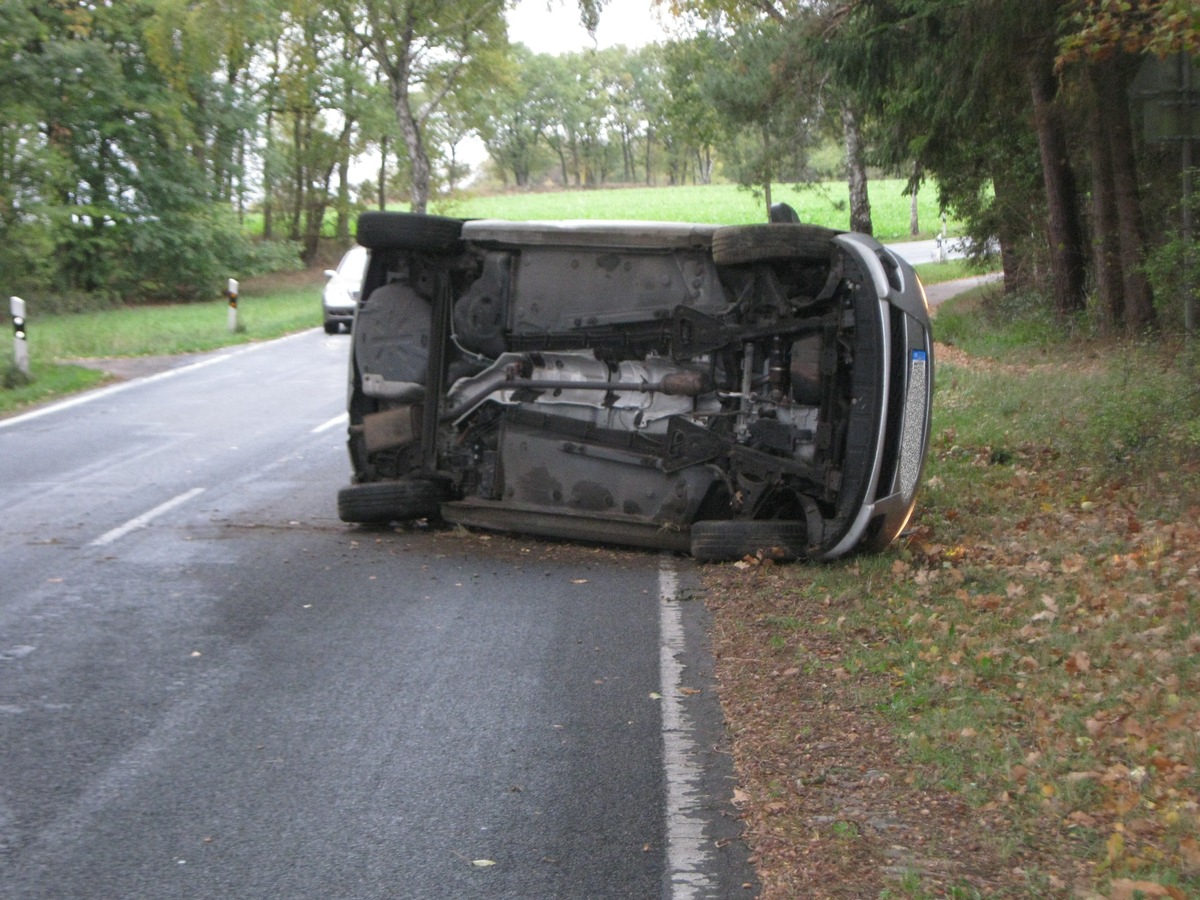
[4,0,262,298]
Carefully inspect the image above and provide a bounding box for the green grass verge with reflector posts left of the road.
[0,272,322,415]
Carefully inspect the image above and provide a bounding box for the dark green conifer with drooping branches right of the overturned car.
[818,0,1085,316]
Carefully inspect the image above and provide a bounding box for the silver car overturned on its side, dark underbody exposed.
[338,208,932,560]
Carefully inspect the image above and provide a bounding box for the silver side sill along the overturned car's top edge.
[462,218,720,250]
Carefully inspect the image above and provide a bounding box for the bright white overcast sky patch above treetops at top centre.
[509,0,670,54]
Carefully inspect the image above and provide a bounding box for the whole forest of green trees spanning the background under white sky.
[0,0,1200,335]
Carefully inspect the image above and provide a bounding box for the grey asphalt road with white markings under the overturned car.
[0,331,754,900]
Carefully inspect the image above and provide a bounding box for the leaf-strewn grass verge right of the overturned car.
[706,295,1200,898]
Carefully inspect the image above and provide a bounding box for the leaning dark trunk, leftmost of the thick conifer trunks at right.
[1027,55,1085,319]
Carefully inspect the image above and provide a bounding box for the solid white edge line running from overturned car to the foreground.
[659,557,716,900]
